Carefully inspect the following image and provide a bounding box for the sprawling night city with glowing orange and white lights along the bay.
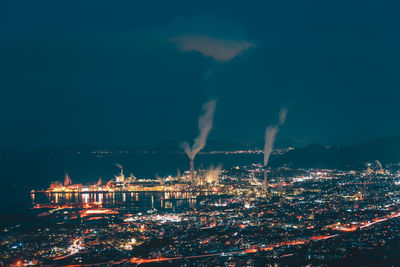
[0,161,400,266]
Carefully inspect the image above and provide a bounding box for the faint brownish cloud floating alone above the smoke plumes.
[172,34,255,62]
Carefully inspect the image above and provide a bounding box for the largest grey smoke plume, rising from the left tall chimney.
[181,99,216,159]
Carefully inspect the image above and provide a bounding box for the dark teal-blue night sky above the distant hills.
[0,0,400,148]
